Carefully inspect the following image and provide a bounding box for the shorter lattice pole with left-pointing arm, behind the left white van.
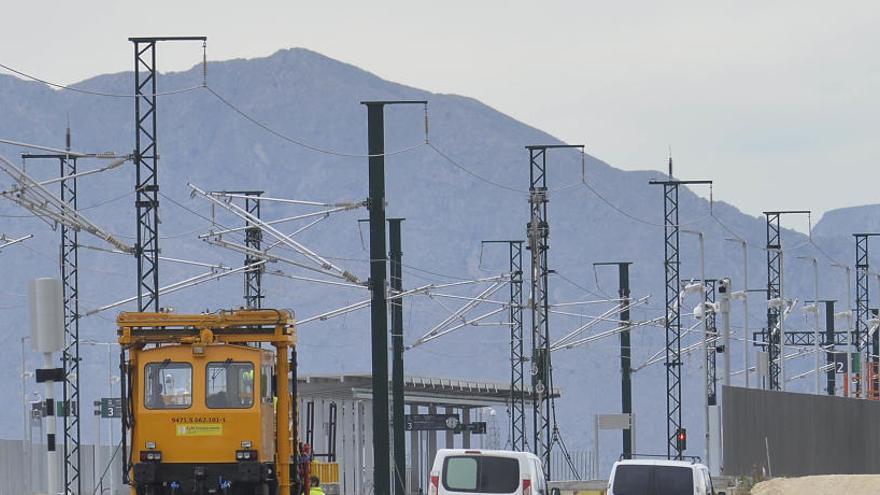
[483,241,528,452]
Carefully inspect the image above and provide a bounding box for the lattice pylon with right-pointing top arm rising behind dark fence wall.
[764,210,810,390]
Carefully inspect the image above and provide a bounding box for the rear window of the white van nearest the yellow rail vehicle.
[443,455,520,493]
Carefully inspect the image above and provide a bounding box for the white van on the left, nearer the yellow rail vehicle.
[428,449,549,495]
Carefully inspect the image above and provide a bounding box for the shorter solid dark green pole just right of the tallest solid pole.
[388,218,406,495]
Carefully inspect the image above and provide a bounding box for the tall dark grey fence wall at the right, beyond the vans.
[722,387,880,476]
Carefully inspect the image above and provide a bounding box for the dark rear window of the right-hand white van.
[612,464,694,495]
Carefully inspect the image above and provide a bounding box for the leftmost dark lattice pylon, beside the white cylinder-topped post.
[22,142,82,494]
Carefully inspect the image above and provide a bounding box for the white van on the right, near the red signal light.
[606,459,725,495]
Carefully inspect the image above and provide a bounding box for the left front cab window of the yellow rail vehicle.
[144,361,192,409]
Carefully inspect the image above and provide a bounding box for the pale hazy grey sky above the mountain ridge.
[0,0,880,223]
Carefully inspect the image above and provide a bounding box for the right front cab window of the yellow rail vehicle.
[205,360,254,409]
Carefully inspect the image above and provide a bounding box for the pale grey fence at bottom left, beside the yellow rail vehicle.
[0,440,128,495]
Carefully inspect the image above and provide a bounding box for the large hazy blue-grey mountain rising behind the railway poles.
[0,49,876,476]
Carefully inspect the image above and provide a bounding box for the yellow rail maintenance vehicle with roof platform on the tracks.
[117,309,308,495]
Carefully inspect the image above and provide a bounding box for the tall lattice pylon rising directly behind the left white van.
[526,144,584,479]
